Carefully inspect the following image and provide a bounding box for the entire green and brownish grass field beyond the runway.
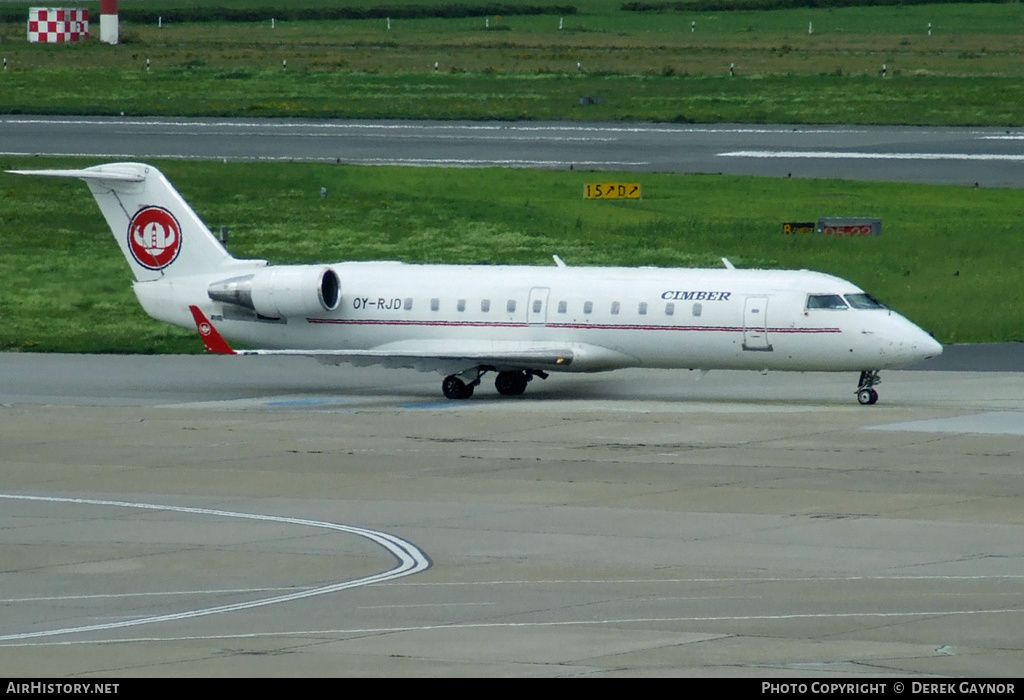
[0,0,1024,126]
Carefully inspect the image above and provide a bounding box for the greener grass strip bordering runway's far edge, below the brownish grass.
[8,71,1024,126]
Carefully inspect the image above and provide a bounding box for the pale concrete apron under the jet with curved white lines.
[0,353,1024,677]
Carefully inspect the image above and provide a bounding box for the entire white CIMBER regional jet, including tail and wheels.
[11,163,942,404]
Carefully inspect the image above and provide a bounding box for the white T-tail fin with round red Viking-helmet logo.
[9,163,243,281]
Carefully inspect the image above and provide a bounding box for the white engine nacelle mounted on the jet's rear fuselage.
[207,265,341,318]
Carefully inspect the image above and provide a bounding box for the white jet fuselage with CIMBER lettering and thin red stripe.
[135,262,941,371]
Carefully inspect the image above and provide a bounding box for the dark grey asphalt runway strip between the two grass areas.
[6,115,1024,187]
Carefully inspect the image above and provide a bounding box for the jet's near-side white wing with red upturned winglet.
[189,306,638,375]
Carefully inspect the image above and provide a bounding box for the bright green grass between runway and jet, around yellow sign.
[0,159,1024,352]
